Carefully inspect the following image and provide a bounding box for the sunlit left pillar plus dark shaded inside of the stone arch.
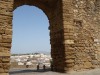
[0,0,64,73]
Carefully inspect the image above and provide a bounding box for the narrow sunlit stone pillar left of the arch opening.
[0,0,13,75]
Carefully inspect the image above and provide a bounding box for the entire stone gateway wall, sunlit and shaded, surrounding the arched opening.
[0,0,100,75]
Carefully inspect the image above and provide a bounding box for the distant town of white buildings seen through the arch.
[10,53,52,68]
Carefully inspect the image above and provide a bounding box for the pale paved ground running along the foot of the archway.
[10,69,100,75]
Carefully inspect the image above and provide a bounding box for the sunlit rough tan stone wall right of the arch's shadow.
[63,0,100,71]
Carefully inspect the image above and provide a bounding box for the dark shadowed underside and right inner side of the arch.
[13,0,63,71]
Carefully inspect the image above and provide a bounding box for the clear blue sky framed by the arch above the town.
[11,5,51,54]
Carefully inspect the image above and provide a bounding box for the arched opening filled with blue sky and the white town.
[11,5,51,70]
